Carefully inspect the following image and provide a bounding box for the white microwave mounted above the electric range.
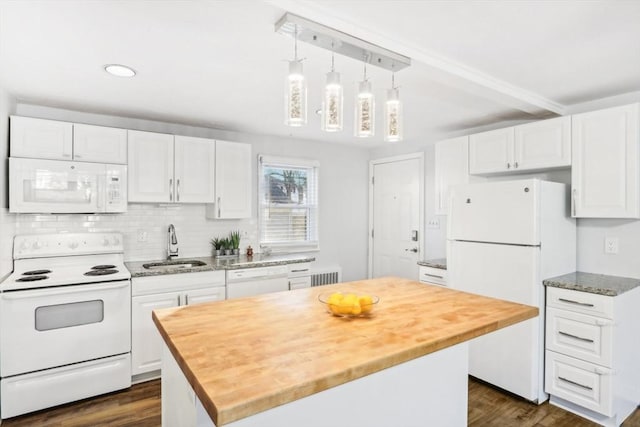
[9,157,127,213]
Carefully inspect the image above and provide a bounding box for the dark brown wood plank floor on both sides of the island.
[2,379,640,427]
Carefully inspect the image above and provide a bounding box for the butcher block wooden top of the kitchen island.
[153,277,538,426]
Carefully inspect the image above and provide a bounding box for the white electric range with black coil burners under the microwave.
[0,233,131,419]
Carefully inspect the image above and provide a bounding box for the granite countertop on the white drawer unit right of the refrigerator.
[542,271,640,297]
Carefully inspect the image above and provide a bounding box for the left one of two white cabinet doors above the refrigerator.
[469,127,514,174]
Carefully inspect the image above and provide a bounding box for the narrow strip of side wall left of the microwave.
[0,81,15,281]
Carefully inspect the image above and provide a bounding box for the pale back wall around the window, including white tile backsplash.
[11,104,369,280]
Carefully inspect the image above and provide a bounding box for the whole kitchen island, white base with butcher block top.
[153,278,538,426]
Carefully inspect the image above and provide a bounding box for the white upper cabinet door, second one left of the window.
[174,135,216,203]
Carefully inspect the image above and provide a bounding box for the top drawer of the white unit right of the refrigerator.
[547,286,613,319]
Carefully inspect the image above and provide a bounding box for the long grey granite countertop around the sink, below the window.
[124,254,315,277]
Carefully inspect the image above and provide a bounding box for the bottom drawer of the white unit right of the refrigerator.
[545,350,613,417]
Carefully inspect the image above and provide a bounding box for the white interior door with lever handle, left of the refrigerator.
[369,153,424,279]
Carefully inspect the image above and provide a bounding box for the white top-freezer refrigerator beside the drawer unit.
[447,179,576,403]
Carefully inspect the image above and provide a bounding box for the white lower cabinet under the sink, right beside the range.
[131,271,226,381]
